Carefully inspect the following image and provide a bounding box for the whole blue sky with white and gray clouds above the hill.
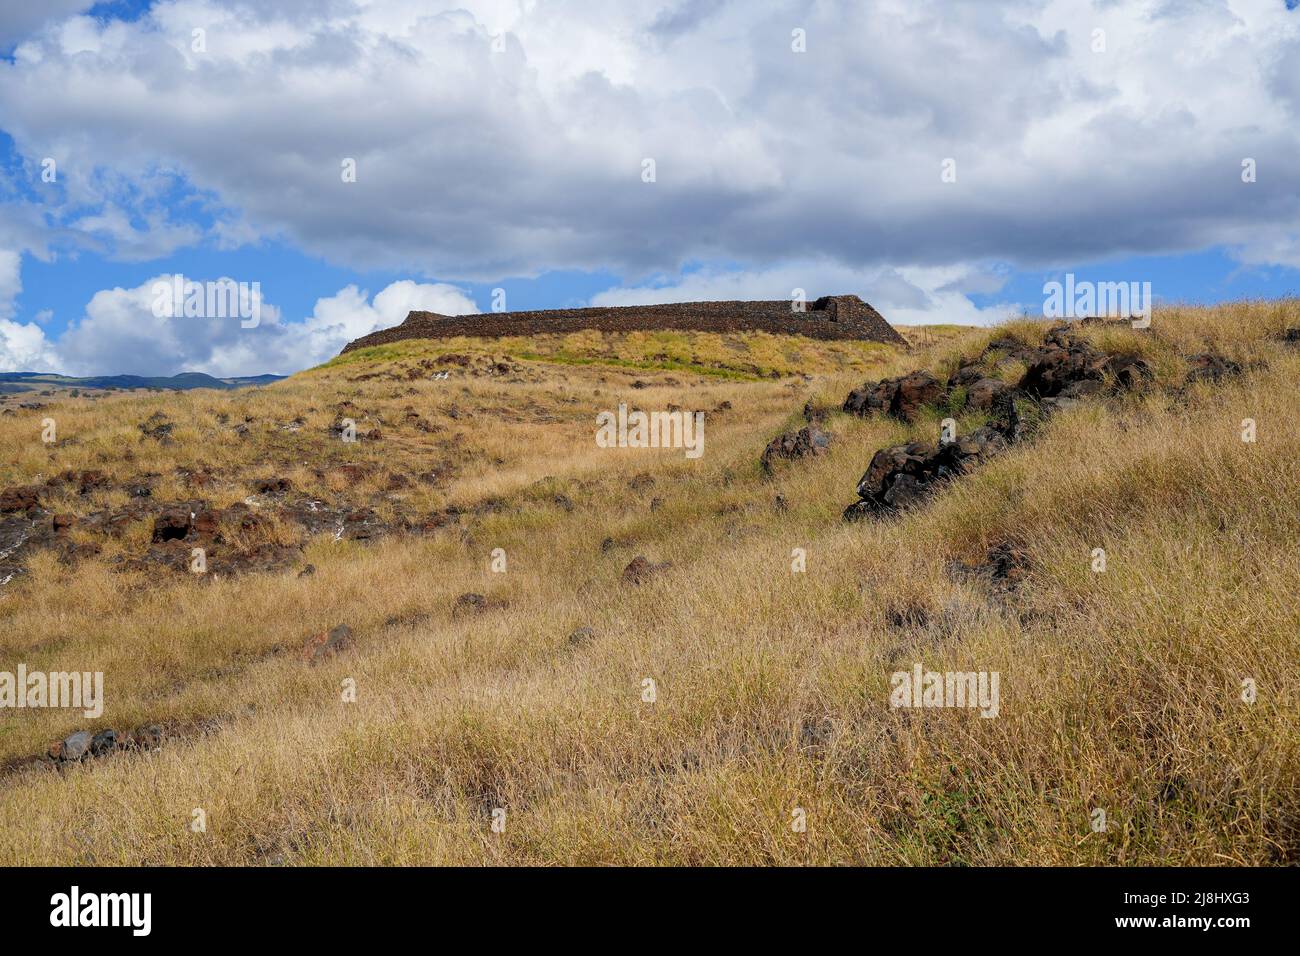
[0,0,1300,375]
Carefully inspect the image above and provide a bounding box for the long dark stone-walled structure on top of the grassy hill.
[343,295,907,352]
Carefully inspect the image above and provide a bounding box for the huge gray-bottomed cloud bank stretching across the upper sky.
[0,0,1300,287]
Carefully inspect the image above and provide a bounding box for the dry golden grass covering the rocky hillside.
[0,302,1300,865]
